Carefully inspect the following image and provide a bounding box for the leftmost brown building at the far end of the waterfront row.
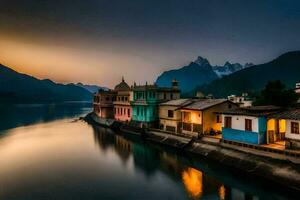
[93,89,117,119]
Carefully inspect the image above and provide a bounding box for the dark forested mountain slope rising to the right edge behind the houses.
[195,51,300,97]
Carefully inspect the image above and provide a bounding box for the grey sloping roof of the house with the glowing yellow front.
[183,99,233,110]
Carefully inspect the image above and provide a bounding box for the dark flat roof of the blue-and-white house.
[219,106,281,117]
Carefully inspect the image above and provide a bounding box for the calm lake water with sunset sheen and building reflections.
[0,103,291,200]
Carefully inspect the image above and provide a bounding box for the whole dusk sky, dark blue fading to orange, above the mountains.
[0,0,300,87]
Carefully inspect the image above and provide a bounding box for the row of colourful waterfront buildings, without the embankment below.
[93,78,300,153]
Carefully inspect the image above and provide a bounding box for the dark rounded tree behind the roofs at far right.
[253,80,299,107]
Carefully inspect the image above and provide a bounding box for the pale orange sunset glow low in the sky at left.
[0,34,164,87]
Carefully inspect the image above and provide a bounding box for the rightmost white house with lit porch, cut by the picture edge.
[270,108,300,150]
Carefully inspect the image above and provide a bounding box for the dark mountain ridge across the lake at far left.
[0,64,92,103]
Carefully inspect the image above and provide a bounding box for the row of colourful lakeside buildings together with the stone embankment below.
[85,78,300,192]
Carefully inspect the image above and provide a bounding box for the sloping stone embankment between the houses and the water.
[83,114,300,192]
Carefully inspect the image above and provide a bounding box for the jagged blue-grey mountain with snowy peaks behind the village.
[156,56,253,93]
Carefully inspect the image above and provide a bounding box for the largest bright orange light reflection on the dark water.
[182,168,203,198]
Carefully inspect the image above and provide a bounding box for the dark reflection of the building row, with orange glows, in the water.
[93,127,246,199]
